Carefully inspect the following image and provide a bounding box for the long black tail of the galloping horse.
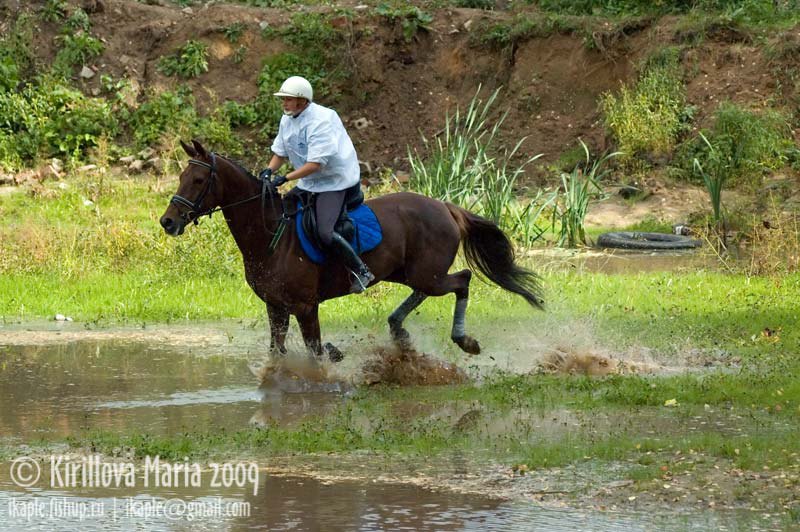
[446,203,544,309]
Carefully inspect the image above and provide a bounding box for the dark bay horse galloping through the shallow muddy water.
[161,140,542,361]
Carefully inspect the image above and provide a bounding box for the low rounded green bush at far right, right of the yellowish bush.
[681,102,793,186]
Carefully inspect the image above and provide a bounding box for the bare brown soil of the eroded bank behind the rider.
[10,0,800,181]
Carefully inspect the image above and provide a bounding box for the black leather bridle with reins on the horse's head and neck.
[169,152,297,253]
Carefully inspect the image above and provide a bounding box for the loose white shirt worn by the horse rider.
[272,102,361,192]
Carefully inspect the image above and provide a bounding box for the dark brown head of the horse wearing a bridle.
[161,140,220,236]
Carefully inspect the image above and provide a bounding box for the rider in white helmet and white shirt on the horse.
[261,76,375,293]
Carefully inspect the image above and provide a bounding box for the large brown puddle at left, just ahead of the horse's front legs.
[0,330,342,441]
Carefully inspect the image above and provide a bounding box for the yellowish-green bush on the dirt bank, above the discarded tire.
[600,49,687,161]
